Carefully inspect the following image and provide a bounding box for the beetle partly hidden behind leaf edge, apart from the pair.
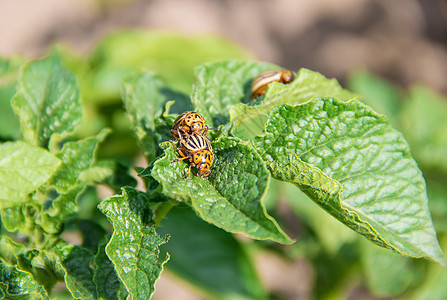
[250,69,295,101]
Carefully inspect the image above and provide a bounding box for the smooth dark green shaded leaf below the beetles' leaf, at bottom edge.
[158,207,266,299]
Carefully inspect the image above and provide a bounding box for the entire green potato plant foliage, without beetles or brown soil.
[0,32,447,299]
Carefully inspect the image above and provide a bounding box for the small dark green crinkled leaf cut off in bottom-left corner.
[0,261,50,300]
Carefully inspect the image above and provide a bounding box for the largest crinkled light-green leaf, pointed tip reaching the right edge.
[254,99,446,265]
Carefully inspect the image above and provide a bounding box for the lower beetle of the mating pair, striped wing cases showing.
[170,133,214,179]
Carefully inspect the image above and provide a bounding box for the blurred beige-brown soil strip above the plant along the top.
[0,0,447,93]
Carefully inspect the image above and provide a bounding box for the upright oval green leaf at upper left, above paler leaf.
[12,55,82,147]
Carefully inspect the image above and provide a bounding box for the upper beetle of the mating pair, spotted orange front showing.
[171,111,216,140]
